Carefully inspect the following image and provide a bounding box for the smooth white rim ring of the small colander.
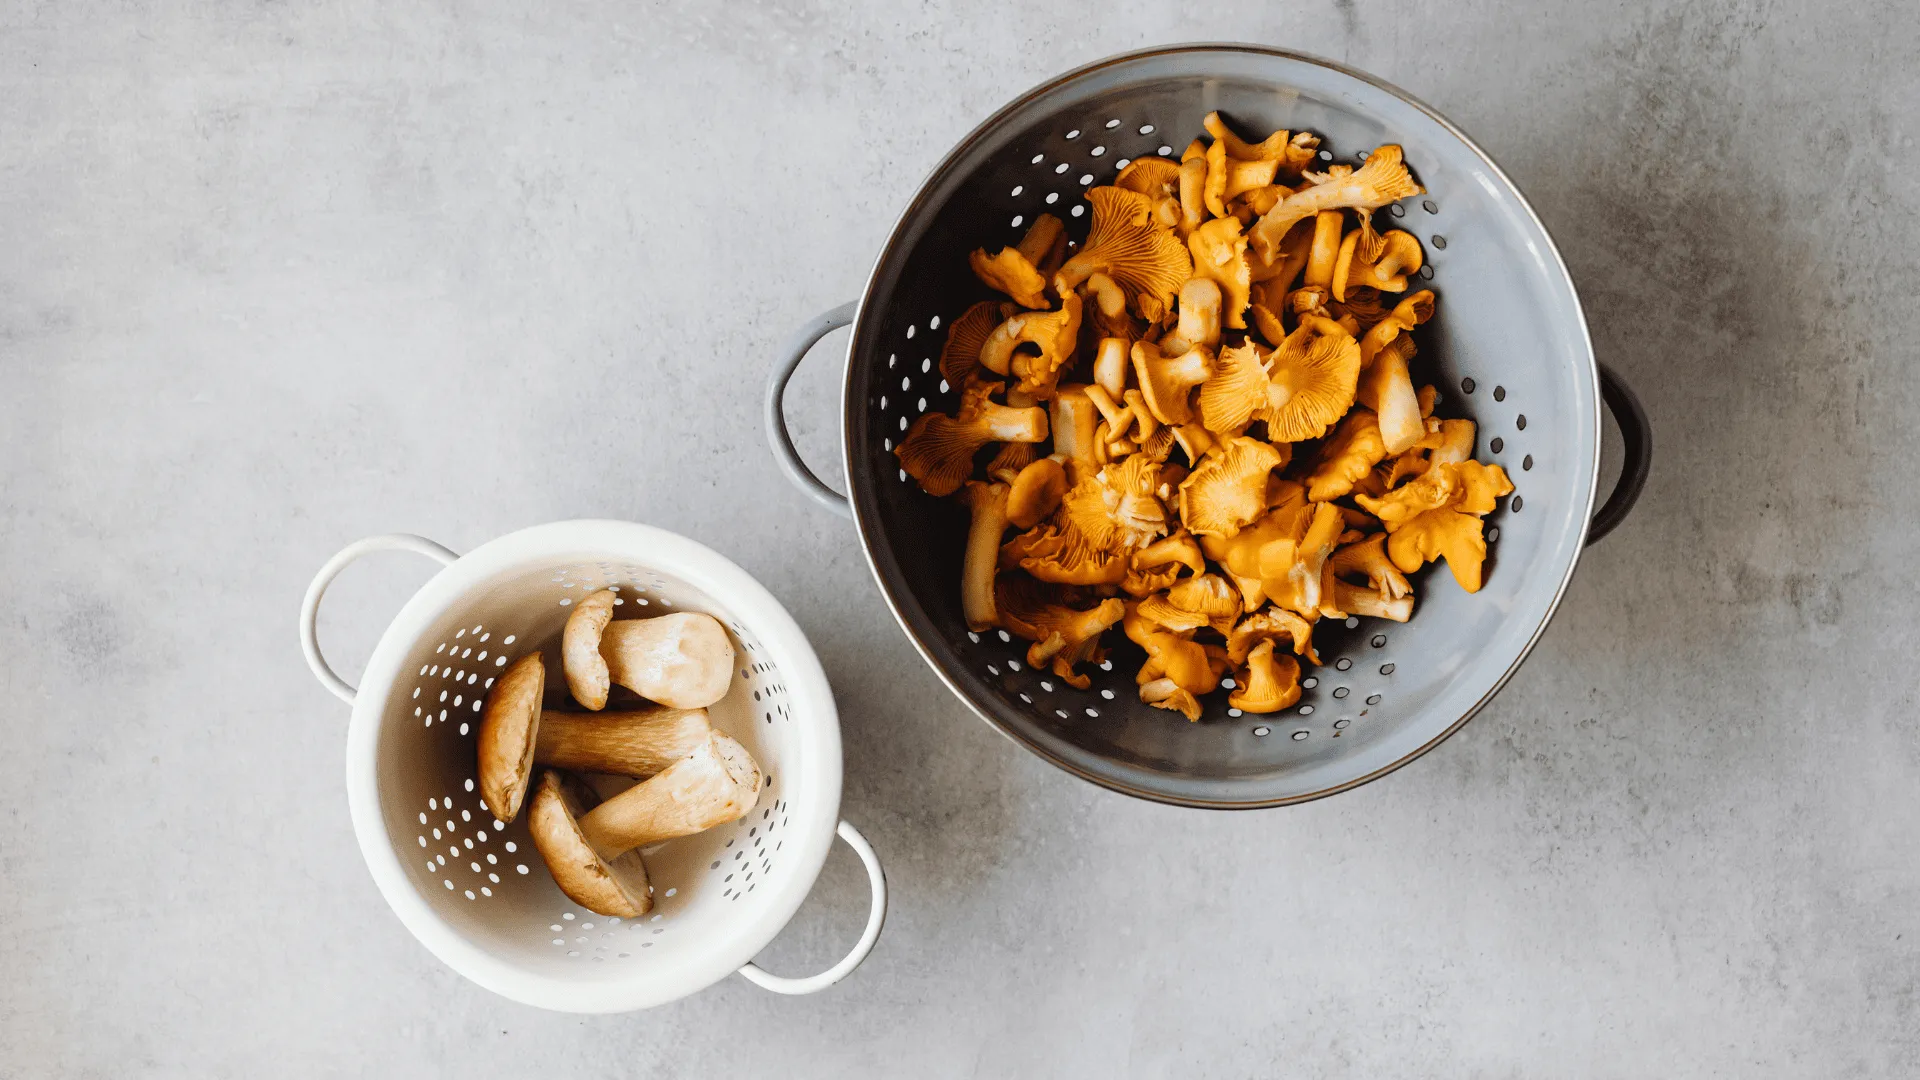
[346,519,843,1013]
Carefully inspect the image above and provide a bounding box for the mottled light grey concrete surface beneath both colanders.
[0,0,1920,1078]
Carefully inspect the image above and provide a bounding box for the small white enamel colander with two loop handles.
[300,521,887,1013]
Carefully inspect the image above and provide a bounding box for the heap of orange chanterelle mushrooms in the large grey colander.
[895,113,1513,721]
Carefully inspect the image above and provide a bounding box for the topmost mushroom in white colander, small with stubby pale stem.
[561,590,733,711]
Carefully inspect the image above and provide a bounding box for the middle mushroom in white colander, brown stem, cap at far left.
[478,653,712,821]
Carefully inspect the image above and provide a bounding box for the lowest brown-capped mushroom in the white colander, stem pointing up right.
[528,732,760,919]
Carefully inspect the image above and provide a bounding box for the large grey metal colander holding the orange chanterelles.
[768,44,1649,807]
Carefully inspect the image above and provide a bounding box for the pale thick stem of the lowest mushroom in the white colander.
[580,732,760,859]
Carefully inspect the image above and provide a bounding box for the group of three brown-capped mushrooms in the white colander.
[480,590,760,917]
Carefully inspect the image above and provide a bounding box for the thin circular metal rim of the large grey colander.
[841,42,1601,809]
